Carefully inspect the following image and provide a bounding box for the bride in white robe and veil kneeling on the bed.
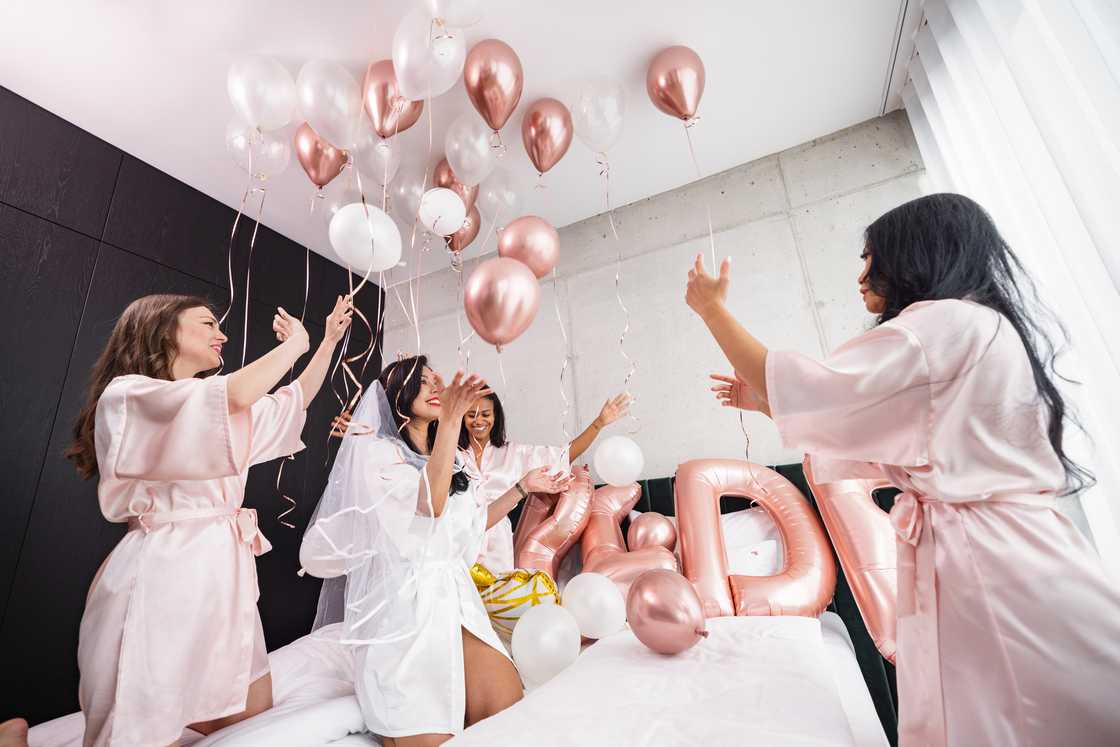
[300,355,570,747]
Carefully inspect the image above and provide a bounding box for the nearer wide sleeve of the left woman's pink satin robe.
[96,376,252,480]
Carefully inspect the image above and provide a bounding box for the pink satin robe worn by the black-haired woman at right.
[766,300,1120,747]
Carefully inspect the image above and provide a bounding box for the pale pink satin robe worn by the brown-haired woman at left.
[78,375,305,746]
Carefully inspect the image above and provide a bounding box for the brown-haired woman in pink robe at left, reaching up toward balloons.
[66,295,352,746]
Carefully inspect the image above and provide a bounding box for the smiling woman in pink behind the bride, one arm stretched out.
[459,392,631,571]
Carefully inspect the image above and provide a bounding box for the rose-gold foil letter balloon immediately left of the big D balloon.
[579,483,679,598]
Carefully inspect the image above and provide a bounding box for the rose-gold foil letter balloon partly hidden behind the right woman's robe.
[803,456,898,663]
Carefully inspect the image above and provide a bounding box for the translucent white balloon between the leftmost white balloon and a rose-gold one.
[296,59,362,148]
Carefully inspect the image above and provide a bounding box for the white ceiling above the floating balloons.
[0,0,904,269]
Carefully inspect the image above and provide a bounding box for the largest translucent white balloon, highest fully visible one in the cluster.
[393,9,467,101]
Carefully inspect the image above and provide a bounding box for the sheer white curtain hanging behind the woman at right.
[903,0,1120,579]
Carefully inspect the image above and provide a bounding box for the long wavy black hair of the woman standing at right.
[864,194,1095,494]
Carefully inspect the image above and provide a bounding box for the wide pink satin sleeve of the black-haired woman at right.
[766,323,931,467]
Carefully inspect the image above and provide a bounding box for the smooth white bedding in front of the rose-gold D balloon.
[448,617,866,747]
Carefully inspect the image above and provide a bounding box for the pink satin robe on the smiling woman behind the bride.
[460,443,571,573]
